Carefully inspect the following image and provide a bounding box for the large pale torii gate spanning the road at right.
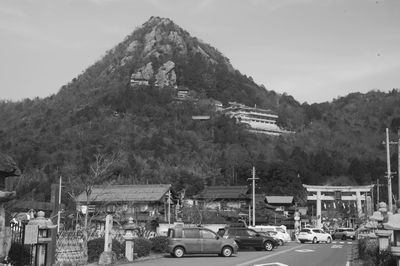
[303,184,374,228]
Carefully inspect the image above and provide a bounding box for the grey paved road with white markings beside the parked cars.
[126,241,356,266]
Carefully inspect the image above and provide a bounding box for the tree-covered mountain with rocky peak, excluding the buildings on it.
[0,17,400,208]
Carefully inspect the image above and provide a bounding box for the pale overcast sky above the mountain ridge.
[0,0,400,103]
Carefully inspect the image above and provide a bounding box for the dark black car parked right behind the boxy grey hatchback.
[224,227,279,251]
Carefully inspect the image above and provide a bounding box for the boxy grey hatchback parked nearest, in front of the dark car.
[168,227,238,258]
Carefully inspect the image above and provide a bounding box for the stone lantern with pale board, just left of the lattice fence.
[25,211,57,266]
